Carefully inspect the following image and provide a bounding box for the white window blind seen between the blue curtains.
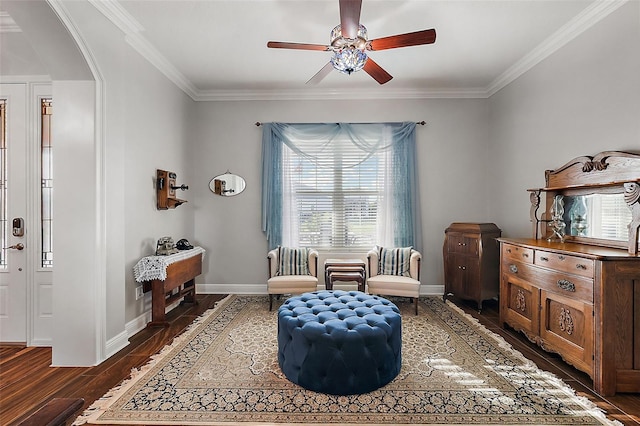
[283,141,389,251]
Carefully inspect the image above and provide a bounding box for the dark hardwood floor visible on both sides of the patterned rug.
[0,295,640,425]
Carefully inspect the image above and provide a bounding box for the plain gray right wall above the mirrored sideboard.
[487,1,640,237]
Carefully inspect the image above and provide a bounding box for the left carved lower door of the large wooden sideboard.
[500,270,540,341]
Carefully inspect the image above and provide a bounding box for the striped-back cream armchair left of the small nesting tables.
[267,247,318,310]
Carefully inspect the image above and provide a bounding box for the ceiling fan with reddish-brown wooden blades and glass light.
[267,0,436,84]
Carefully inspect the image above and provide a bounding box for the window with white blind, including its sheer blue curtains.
[262,123,421,251]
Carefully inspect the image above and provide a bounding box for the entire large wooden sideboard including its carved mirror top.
[498,151,640,396]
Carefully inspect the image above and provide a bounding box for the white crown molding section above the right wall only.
[486,0,628,97]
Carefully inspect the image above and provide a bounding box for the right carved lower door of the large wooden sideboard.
[540,290,594,374]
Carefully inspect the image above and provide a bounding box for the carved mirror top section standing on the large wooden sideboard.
[529,151,640,255]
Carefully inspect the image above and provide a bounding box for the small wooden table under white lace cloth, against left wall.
[143,254,202,327]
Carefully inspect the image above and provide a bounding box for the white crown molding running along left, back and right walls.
[89,0,629,101]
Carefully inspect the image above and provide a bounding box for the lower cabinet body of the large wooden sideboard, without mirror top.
[499,238,640,396]
